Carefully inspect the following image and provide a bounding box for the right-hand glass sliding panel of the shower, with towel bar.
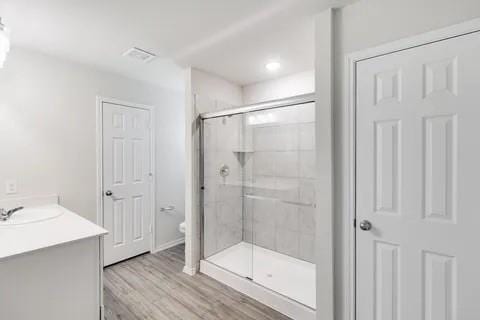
[244,103,316,308]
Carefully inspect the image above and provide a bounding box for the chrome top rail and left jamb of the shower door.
[198,93,315,260]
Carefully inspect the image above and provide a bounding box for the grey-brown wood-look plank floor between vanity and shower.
[104,245,290,320]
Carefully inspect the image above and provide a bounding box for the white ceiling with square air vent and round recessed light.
[0,0,344,89]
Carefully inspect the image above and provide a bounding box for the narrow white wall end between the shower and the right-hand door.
[315,9,335,320]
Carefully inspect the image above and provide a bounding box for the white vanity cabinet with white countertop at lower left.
[0,195,106,320]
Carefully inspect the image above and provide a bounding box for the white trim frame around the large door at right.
[341,18,480,320]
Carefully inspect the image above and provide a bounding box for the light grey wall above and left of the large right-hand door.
[328,0,480,319]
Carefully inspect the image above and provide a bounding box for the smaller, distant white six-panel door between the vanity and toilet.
[103,103,152,265]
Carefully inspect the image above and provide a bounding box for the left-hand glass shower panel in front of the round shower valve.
[202,115,253,279]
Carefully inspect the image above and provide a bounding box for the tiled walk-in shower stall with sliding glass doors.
[200,95,316,318]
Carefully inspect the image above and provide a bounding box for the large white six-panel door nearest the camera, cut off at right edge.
[356,33,480,320]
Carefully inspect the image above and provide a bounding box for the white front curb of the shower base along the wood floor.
[200,260,316,320]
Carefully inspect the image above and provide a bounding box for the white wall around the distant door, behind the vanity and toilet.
[0,48,184,249]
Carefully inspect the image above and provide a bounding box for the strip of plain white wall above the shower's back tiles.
[243,70,315,104]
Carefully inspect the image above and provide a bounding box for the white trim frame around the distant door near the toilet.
[96,96,156,258]
